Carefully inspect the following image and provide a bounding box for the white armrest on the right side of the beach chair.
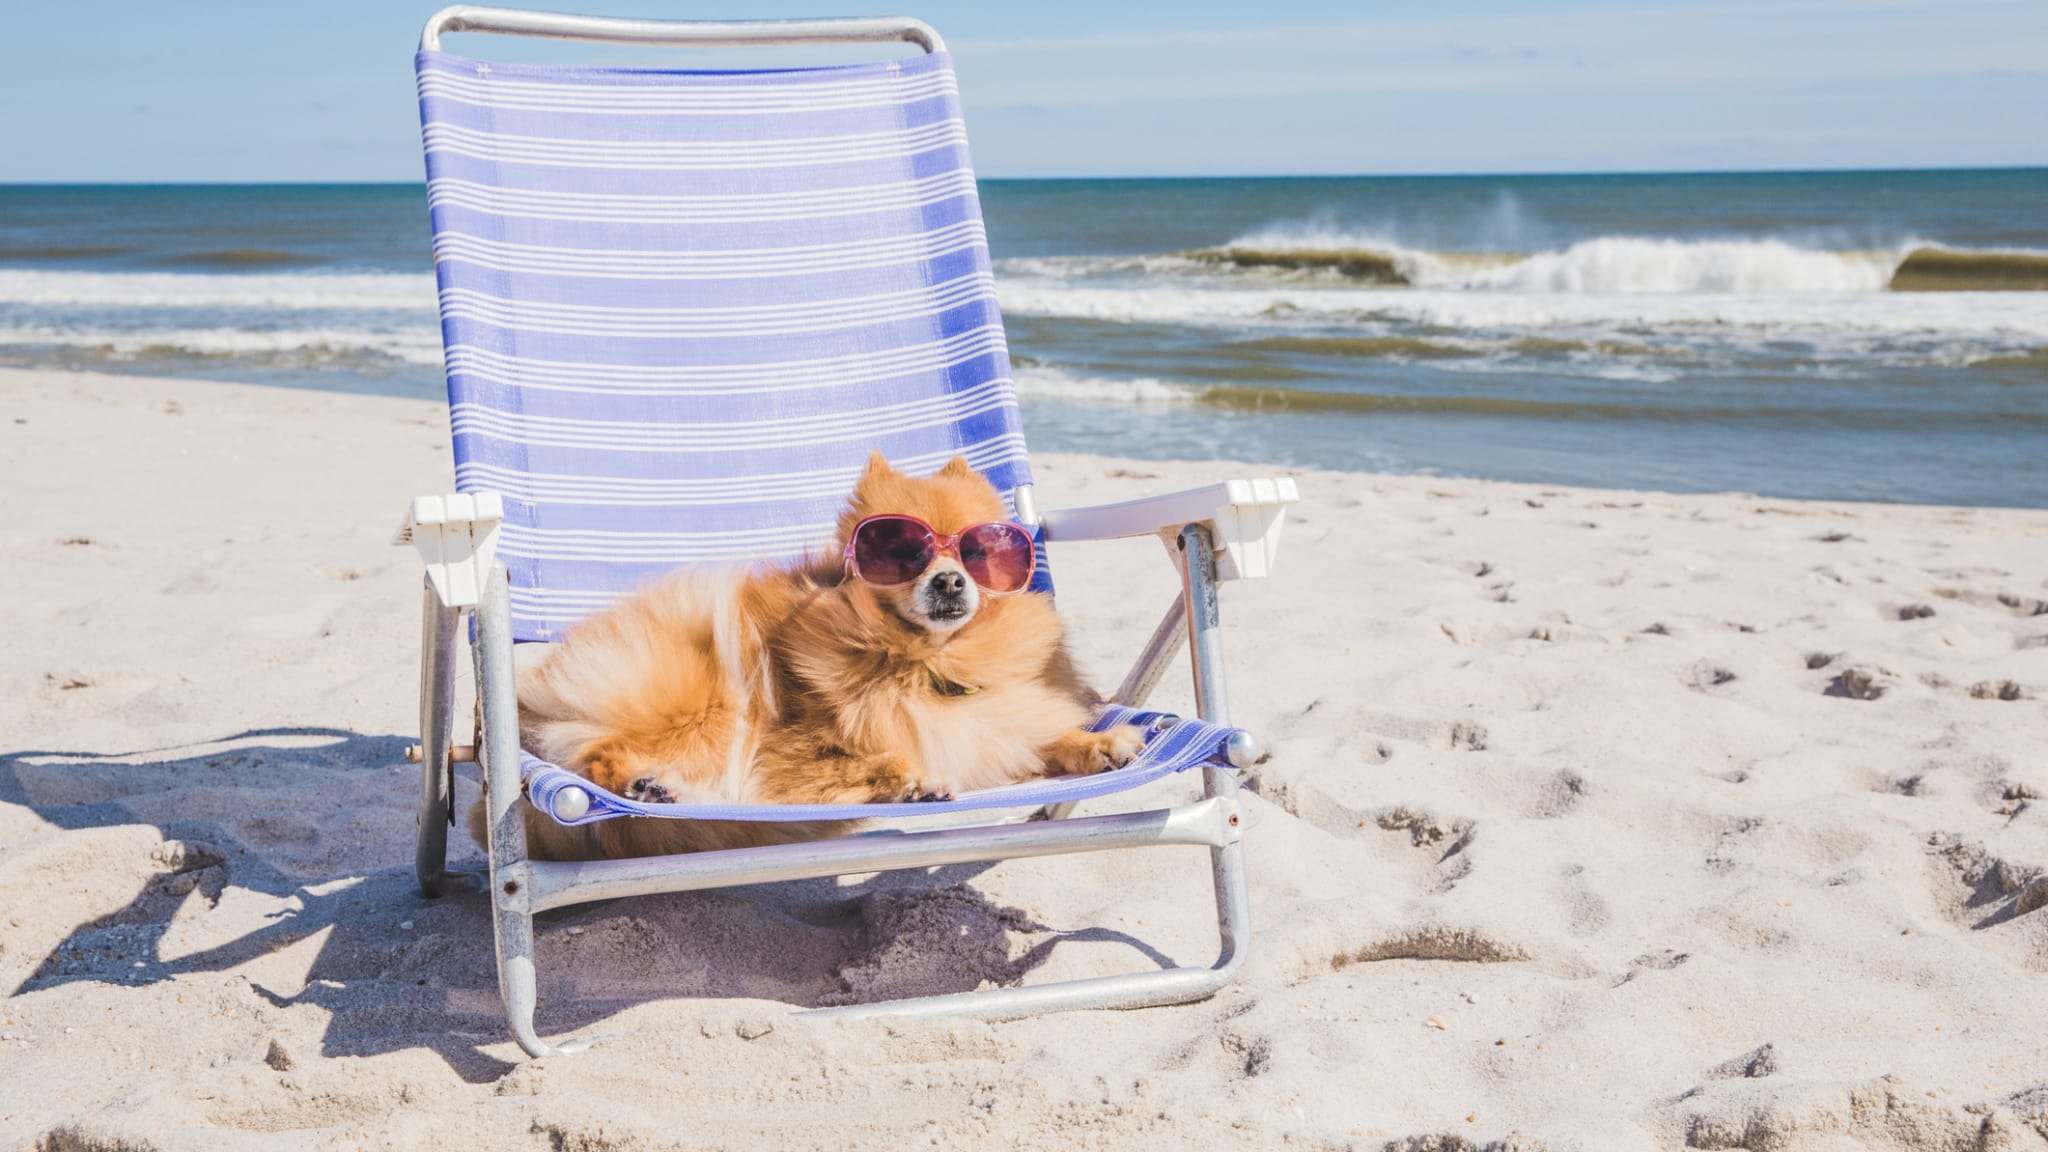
[1040,476,1300,580]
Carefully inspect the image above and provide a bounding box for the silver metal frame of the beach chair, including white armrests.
[401,6,1294,1058]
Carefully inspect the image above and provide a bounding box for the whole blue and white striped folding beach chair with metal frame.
[401,6,1294,1056]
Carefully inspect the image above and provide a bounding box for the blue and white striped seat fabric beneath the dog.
[520,703,1239,826]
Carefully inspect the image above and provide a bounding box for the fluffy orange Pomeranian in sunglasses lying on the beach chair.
[489,453,1145,859]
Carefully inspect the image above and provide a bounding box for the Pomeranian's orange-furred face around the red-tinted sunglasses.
[840,453,1006,635]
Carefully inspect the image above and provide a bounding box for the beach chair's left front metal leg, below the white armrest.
[477,566,588,1058]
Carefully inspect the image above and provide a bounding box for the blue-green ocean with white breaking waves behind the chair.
[0,170,2048,506]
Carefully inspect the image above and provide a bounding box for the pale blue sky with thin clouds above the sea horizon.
[0,0,2048,182]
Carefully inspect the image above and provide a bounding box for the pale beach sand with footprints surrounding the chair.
[0,371,2048,1150]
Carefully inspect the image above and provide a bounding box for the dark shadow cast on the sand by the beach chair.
[0,728,1174,1082]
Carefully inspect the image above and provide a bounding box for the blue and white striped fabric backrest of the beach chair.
[418,42,1030,640]
